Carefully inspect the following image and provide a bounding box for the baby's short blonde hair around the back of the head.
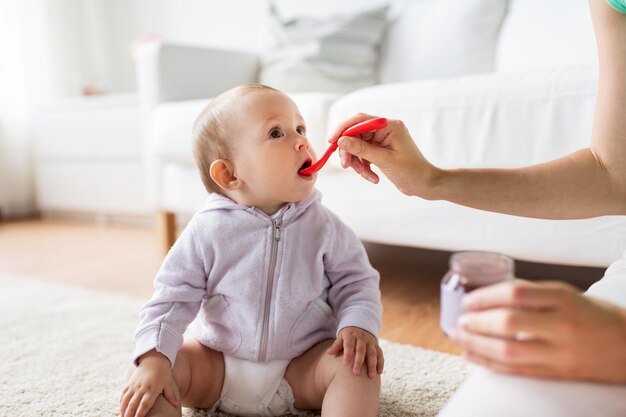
[192,84,279,193]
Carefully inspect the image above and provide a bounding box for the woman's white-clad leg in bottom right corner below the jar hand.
[439,368,626,417]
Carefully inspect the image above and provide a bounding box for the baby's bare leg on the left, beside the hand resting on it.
[134,339,224,417]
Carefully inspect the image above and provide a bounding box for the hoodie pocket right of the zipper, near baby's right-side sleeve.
[287,298,337,356]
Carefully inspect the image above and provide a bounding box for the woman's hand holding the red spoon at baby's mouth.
[328,113,440,198]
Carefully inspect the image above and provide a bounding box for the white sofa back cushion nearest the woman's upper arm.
[496,0,597,71]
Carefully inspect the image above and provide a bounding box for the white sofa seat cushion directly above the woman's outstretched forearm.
[328,66,597,167]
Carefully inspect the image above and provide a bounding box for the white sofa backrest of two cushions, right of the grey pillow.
[380,0,597,83]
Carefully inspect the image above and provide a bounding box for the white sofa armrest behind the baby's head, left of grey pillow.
[136,42,259,111]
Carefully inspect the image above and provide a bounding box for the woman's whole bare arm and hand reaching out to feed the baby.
[333,0,626,219]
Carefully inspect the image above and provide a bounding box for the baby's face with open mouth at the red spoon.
[227,90,317,214]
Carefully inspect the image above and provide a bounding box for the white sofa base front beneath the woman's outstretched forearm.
[317,170,626,267]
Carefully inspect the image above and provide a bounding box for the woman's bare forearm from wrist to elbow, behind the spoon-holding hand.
[429,149,626,219]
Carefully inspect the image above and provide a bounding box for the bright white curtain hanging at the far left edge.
[0,0,50,217]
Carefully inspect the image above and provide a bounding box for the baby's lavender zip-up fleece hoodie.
[134,190,382,365]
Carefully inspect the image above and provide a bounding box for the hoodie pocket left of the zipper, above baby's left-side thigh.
[201,294,241,353]
